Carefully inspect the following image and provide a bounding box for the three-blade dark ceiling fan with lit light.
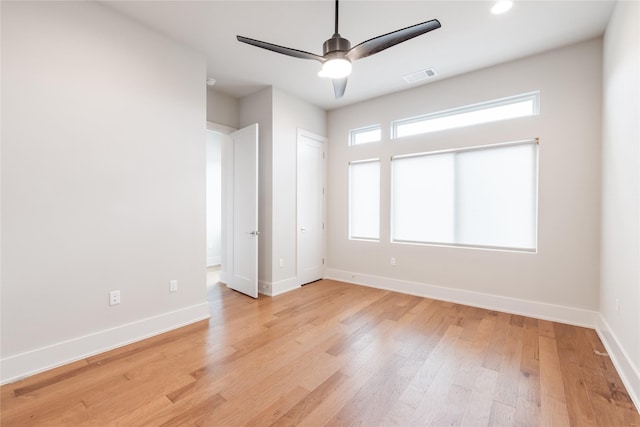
[236,0,441,98]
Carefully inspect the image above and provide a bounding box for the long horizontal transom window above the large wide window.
[392,92,540,138]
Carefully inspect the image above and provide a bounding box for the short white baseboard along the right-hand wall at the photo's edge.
[596,314,640,412]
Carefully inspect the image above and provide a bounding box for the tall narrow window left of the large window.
[349,159,380,240]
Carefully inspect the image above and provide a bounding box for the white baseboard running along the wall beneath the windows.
[326,269,598,329]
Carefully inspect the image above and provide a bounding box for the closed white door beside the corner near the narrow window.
[297,131,325,285]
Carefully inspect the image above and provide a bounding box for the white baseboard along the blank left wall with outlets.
[0,303,211,384]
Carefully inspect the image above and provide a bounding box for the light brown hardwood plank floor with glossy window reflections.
[1,280,640,427]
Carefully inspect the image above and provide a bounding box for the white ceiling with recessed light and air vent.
[102,0,614,110]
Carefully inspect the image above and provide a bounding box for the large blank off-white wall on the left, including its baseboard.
[0,2,208,382]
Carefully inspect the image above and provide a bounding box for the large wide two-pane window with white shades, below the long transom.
[391,140,538,251]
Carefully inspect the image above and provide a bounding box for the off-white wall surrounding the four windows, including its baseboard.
[327,39,602,324]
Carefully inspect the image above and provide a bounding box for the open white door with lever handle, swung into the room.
[227,124,259,298]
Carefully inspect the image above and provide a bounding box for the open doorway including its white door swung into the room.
[206,122,260,298]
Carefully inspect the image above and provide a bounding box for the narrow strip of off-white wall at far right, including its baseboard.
[600,1,640,408]
